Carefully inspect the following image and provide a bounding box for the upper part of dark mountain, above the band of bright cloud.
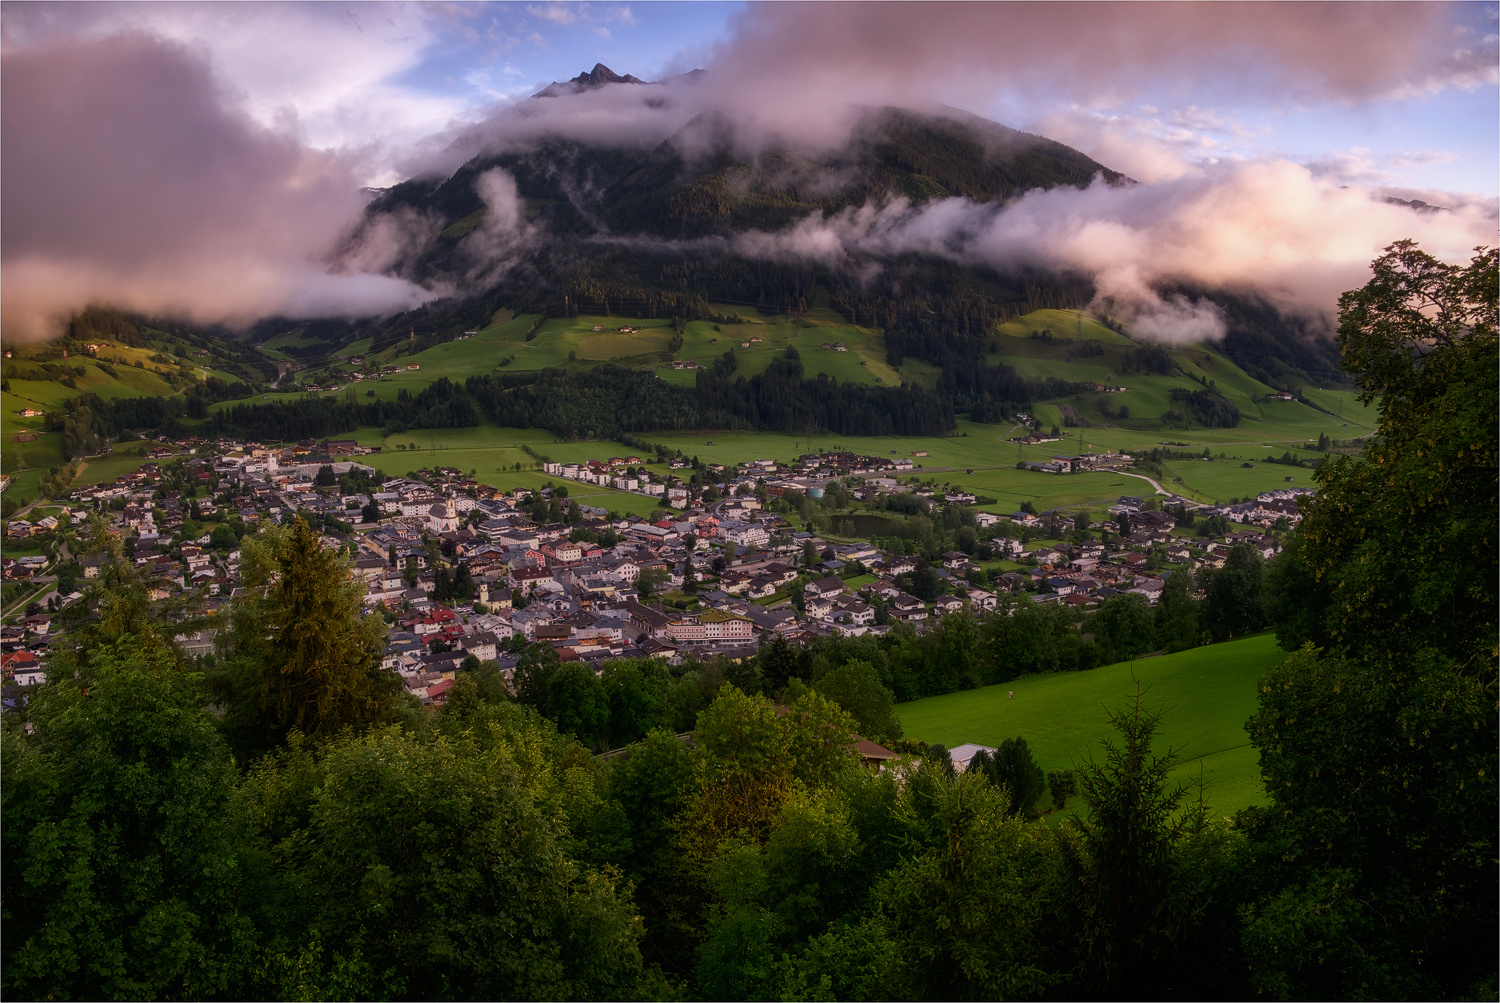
[368,97,1130,254]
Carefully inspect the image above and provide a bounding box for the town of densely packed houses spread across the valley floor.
[0,439,1310,706]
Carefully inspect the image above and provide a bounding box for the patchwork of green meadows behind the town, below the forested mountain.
[0,302,1376,513]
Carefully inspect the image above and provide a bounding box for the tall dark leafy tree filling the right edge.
[1244,241,1500,997]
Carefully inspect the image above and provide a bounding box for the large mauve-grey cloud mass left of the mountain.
[0,33,431,339]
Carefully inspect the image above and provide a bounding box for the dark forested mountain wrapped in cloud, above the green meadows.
[351,82,1133,340]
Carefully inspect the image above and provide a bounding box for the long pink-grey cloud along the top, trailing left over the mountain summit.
[423,3,1476,180]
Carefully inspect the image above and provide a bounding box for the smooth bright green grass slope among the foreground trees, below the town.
[897,634,1287,814]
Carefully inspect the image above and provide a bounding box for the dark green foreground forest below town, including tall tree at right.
[0,241,1500,1000]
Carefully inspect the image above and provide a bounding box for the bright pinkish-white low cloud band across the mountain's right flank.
[735,160,1497,342]
